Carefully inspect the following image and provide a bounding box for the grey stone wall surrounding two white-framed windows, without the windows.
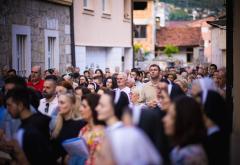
[0,0,71,75]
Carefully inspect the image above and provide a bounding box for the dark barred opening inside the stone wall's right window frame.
[47,37,56,69]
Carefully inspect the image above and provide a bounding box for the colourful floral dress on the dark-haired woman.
[79,125,104,165]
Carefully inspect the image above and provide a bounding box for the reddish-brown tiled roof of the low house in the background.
[156,27,203,47]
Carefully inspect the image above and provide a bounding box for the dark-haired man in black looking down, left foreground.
[3,87,55,165]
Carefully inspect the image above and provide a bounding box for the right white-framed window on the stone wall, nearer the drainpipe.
[44,29,60,70]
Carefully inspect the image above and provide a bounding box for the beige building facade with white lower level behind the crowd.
[73,0,133,71]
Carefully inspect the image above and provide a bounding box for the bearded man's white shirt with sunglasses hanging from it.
[38,96,58,117]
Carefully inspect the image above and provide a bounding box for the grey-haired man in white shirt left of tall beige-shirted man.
[116,72,130,102]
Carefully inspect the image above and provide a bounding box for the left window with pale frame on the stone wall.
[12,25,32,76]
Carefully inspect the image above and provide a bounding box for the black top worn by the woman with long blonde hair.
[52,119,86,159]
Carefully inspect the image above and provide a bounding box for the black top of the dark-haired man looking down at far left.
[20,114,55,165]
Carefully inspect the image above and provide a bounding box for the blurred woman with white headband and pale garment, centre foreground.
[96,90,162,164]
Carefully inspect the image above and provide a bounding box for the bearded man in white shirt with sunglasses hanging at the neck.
[38,75,58,117]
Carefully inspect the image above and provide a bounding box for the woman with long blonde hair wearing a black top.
[52,93,86,162]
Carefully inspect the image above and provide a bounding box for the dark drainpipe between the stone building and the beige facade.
[70,1,76,67]
